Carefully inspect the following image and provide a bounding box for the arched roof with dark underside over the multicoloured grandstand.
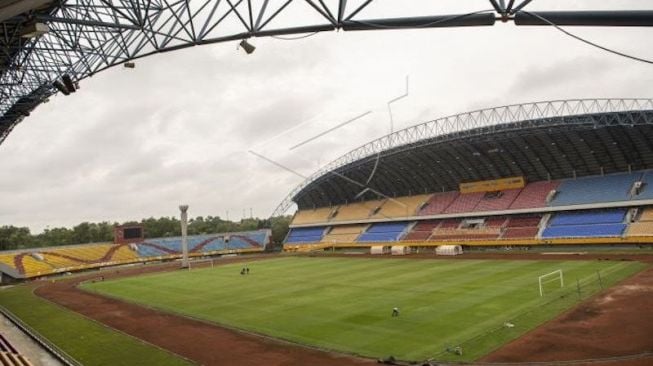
[275,99,653,214]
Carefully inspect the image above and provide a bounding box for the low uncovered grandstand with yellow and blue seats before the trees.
[0,229,271,279]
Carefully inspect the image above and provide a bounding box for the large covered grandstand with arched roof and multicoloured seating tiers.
[280,99,653,250]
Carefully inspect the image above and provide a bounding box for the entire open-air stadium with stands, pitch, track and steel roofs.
[0,1,653,366]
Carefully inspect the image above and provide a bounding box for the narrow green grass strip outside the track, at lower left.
[0,286,191,366]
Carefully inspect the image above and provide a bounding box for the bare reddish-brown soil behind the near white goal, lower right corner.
[481,256,653,366]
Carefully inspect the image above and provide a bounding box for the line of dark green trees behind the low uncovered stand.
[0,216,291,250]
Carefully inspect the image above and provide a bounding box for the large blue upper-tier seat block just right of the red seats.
[549,173,641,206]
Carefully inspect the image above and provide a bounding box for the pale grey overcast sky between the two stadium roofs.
[0,0,653,232]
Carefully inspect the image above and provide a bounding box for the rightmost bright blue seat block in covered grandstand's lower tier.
[542,209,626,238]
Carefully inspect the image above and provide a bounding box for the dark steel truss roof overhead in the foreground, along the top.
[0,0,653,144]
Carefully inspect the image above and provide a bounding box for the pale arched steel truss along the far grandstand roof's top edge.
[273,99,653,216]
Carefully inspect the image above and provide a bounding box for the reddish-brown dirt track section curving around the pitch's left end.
[36,264,374,366]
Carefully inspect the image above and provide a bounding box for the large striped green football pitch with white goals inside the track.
[84,257,645,361]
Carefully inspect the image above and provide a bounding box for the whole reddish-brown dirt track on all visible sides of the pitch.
[36,254,653,366]
